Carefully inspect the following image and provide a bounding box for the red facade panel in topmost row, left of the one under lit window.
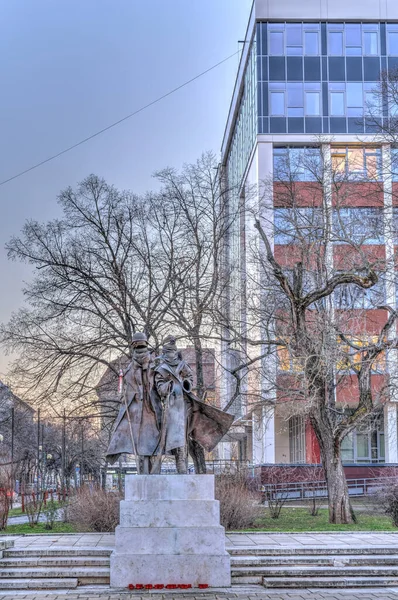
[274,181,322,208]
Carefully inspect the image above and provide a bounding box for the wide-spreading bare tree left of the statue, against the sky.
[0,175,175,409]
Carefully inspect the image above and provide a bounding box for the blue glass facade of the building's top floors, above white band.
[256,23,398,134]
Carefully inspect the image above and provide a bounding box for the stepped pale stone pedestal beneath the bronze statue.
[111,475,231,588]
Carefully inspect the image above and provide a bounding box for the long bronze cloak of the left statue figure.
[106,359,162,464]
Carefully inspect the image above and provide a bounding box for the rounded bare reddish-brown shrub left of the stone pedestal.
[67,487,121,532]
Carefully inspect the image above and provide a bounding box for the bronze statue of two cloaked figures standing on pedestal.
[106,333,234,474]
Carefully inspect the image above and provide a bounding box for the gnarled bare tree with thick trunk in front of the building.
[227,148,397,523]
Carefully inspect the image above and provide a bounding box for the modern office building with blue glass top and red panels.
[222,0,398,465]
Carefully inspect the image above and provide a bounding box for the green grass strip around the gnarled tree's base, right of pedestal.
[246,507,398,532]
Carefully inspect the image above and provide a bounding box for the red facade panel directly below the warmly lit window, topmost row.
[333,181,384,208]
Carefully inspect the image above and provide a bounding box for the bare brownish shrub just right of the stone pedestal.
[216,473,261,529]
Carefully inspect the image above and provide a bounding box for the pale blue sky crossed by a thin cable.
[0,0,252,373]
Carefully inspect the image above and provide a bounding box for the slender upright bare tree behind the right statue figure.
[152,153,236,472]
